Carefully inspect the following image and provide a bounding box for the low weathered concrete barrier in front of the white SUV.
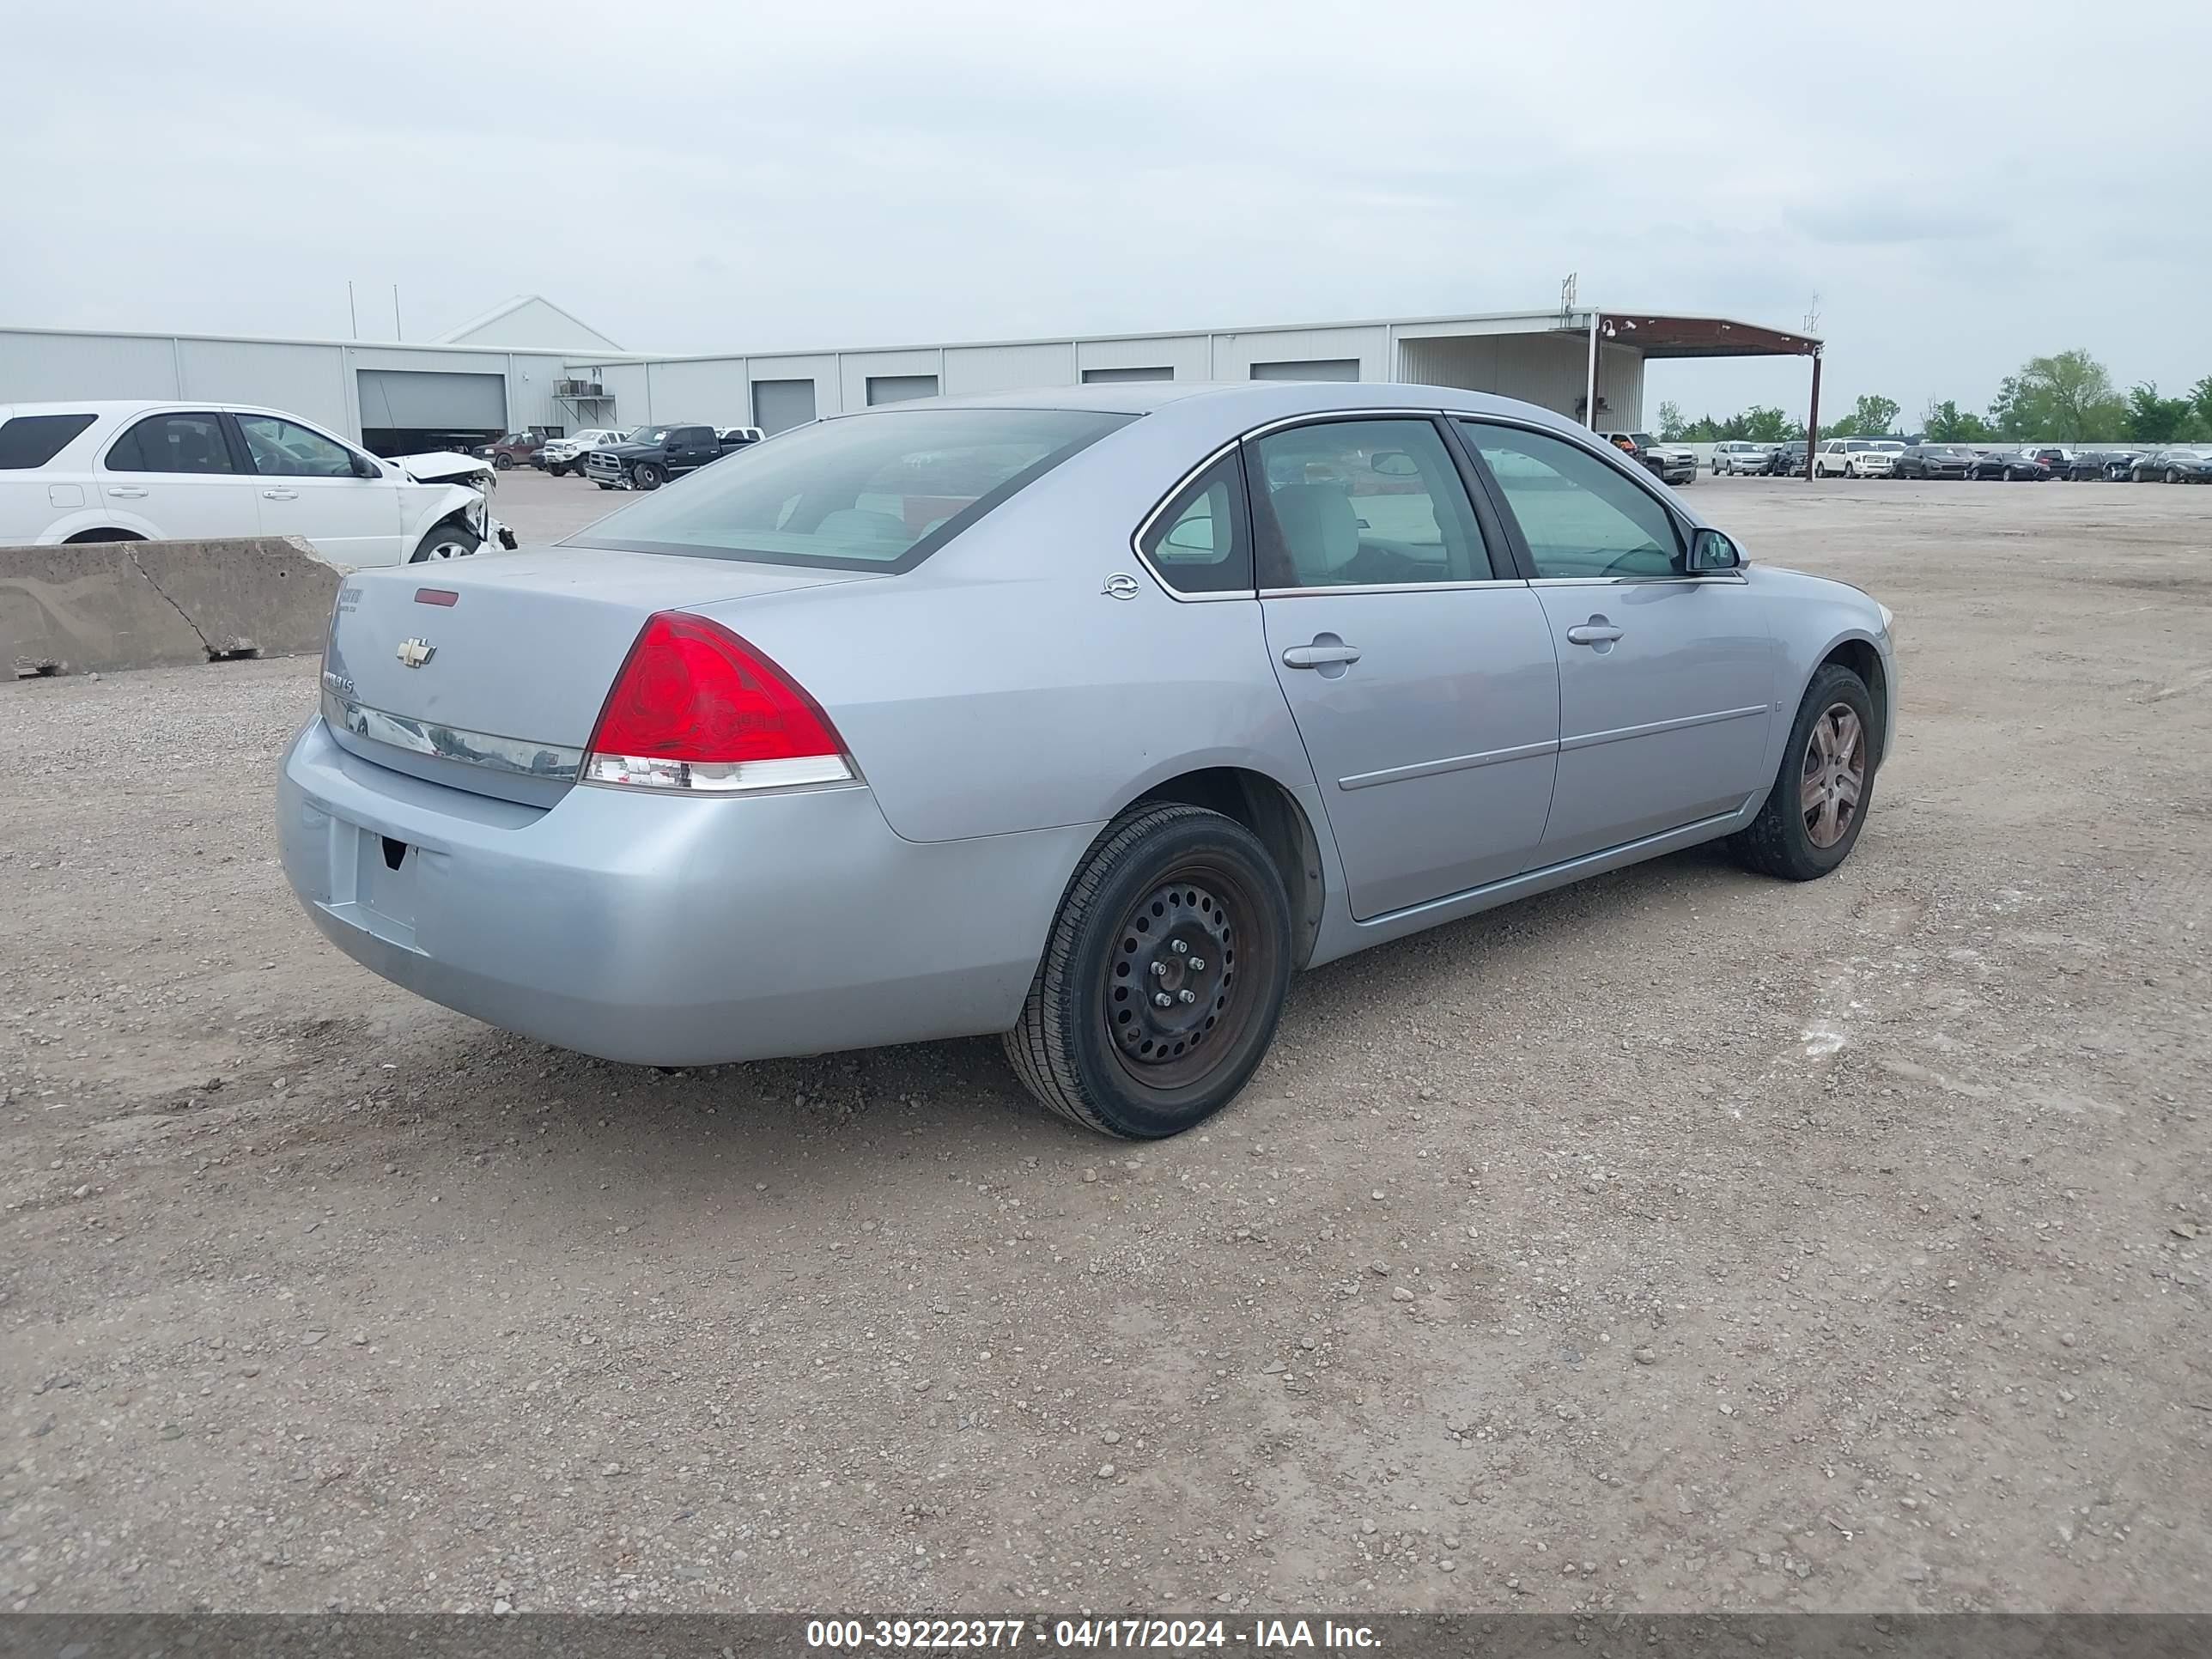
[0,535,338,677]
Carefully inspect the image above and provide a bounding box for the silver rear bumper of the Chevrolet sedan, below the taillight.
[276,719,1095,1066]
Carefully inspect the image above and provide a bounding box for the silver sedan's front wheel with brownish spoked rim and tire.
[1728,664,1878,880]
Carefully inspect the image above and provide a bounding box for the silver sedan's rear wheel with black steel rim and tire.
[1005,805,1290,1139]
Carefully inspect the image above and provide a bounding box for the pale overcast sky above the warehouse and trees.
[0,0,2212,420]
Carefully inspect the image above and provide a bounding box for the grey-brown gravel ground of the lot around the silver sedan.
[0,476,2212,1613]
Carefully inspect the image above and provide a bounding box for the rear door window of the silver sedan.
[1249,418,1491,588]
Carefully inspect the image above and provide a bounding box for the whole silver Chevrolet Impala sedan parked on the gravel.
[279,383,1896,1137]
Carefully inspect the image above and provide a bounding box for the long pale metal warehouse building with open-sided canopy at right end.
[0,296,1820,453]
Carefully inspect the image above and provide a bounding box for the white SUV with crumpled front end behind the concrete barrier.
[0,400,515,568]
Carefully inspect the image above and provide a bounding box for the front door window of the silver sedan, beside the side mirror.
[1460,420,1683,580]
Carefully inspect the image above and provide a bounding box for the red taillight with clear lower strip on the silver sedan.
[584,611,852,792]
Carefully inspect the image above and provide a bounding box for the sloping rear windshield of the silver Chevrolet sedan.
[566,410,1134,571]
